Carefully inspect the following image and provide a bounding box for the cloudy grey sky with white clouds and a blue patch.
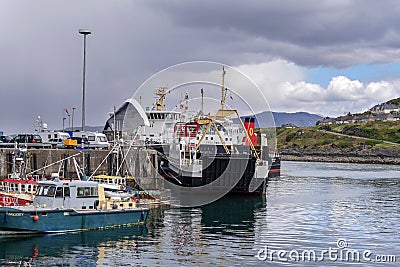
[0,0,400,134]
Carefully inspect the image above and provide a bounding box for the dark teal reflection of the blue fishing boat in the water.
[0,225,147,266]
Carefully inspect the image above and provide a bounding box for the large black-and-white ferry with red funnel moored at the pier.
[104,68,280,194]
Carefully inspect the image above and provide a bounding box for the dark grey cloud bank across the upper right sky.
[148,0,400,67]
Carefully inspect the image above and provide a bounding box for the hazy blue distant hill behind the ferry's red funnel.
[250,111,324,128]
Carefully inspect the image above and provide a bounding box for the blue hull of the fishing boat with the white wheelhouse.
[0,208,148,233]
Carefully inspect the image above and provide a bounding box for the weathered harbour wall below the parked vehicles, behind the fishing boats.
[0,147,162,179]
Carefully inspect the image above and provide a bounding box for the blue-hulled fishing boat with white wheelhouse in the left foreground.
[0,179,148,234]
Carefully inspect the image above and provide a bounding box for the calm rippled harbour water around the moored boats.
[0,162,400,266]
